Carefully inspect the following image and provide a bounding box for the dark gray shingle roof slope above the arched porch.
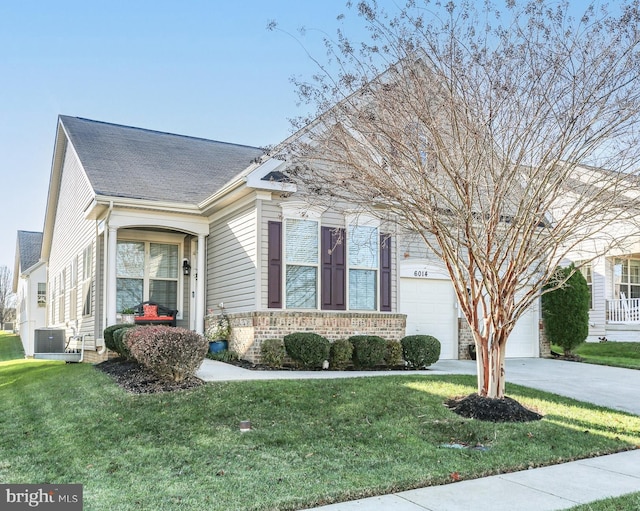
[60,115,264,204]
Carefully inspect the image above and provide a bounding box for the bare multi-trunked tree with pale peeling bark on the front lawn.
[272,0,640,404]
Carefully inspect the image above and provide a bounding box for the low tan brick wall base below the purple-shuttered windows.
[212,311,407,363]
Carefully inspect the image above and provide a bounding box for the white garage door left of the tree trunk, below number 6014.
[400,277,458,359]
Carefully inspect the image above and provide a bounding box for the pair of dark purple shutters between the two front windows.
[320,227,347,310]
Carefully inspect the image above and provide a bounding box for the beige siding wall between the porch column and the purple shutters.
[207,203,258,312]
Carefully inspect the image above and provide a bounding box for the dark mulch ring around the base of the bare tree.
[445,394,542,422]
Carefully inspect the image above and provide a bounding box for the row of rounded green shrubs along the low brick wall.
[261,332,440,370]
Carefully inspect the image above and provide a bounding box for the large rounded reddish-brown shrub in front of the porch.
[124,325,209,382]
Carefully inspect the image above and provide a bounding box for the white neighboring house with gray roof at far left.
[13,231,47,357]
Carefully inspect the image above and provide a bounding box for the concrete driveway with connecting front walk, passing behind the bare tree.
[197,358,640,415]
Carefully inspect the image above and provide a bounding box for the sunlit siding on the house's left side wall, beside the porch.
[47,143,97,338]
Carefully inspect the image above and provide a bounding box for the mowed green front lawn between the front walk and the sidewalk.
[0,360,640,511]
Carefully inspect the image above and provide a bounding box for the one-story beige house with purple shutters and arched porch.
[33,116,540,361]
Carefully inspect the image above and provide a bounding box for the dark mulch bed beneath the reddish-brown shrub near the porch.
[95,358,204,394]
